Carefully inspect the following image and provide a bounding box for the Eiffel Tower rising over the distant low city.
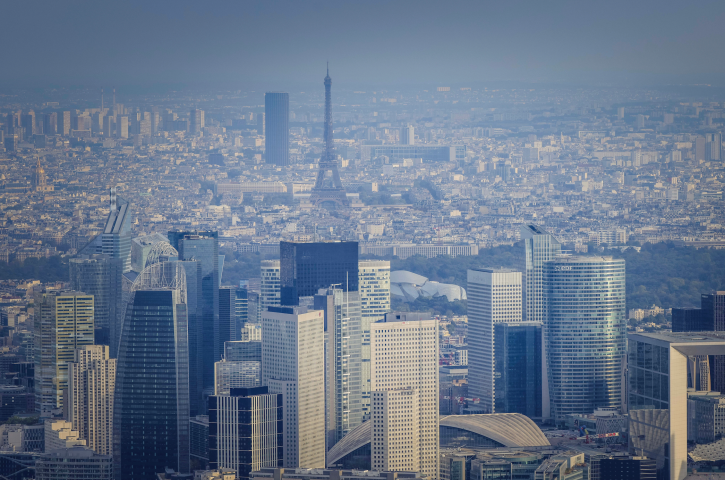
[310,65,350,208]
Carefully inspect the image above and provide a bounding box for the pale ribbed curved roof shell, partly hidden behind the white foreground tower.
[327,413,551,466]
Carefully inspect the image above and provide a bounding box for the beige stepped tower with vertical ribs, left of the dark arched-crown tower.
[67,345,116,455]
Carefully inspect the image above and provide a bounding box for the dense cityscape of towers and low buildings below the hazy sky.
[0,3,725,480]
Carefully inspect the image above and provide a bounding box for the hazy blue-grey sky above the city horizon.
[0,0,725,89]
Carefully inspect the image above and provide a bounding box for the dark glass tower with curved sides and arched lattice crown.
[113,262,189,480]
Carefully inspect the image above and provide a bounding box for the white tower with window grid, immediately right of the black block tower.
[358,260,390,420]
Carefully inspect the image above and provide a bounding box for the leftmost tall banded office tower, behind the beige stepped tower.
[33,291,93,412]
